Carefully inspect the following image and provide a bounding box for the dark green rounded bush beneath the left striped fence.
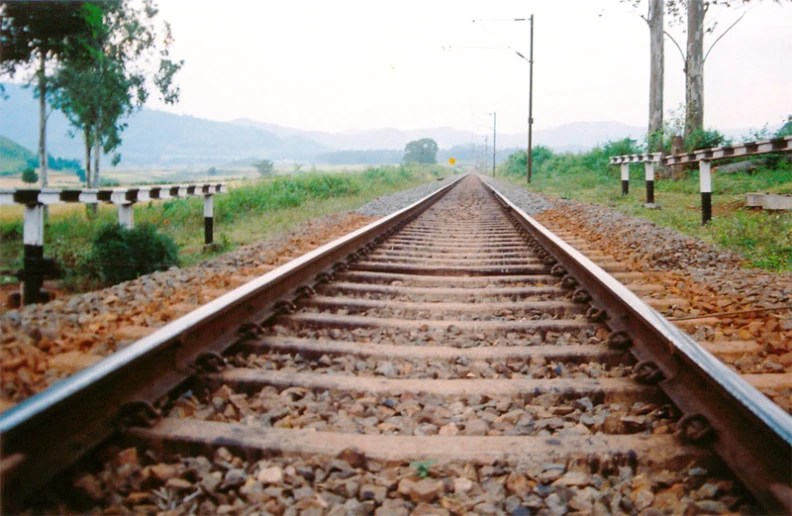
[91,224,179,284]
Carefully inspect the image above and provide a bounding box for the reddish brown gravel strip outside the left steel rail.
[0,213,373,411]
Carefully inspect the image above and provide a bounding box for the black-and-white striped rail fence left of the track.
[0,183,228,304]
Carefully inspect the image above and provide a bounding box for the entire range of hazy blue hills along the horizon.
[0,83,740,168]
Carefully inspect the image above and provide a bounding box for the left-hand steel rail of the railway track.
[0,176,465,512]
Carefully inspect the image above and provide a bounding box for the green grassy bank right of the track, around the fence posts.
[499,146,792,272]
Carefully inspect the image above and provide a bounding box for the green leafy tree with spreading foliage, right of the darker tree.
[50,0,184,187]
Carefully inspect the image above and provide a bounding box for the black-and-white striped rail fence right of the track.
[610,136,792,224]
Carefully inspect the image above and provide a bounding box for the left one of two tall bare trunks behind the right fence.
[647,0,665,152]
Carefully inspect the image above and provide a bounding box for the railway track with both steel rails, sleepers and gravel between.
[0,177,792,514]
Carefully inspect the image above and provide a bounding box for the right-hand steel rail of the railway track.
[485,179,792,514]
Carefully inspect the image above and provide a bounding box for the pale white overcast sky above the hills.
[144,0,792,133]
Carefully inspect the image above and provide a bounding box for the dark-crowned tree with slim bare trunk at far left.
[0,1,87,187]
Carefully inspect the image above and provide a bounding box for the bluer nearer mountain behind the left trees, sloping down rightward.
[0,84,328,167]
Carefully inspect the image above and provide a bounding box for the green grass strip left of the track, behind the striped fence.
[0,166,451,291]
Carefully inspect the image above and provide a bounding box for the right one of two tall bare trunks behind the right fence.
[685,0,704,138]
